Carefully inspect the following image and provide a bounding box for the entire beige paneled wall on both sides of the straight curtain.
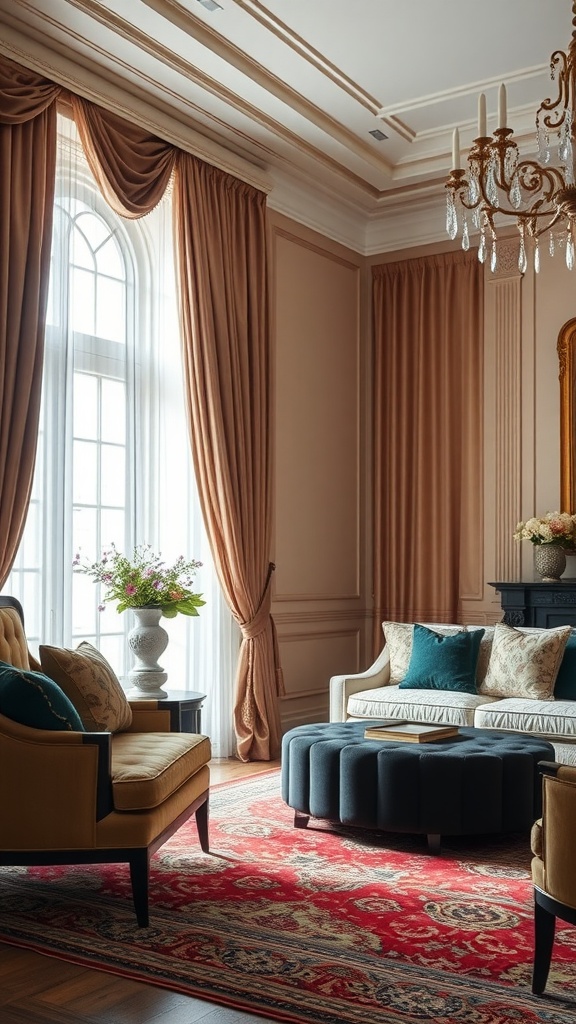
[271,213,576,729]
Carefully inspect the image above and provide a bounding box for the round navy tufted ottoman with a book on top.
[282,722,554,852]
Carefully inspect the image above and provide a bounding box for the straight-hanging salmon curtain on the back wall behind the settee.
[373,251,483,649]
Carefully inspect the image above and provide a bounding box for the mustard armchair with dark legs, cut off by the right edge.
[531,762,576,995]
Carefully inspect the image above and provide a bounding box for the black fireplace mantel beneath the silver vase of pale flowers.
[488,579,576,629]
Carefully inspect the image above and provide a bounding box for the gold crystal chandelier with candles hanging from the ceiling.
[446,0,576,273]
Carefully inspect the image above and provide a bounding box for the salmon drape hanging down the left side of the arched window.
[0,56,60,586]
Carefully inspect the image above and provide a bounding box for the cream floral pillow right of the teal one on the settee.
[480,623,572,700]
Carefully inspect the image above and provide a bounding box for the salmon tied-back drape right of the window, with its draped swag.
[73,96,282,761]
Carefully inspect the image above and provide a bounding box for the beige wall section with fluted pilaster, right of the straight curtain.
[479,237,576,622]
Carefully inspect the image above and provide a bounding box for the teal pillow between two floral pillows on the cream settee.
[399,623,484,693]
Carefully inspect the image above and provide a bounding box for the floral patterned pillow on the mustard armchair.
[40,641,132,732]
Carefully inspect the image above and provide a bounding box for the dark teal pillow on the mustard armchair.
[0,662,86,732]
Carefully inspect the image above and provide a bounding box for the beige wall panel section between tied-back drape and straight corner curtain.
[271,215,371,728]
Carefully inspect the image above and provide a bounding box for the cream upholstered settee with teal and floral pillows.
[330,623,576,765]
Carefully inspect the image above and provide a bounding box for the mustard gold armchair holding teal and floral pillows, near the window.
[0,597,211,926]
